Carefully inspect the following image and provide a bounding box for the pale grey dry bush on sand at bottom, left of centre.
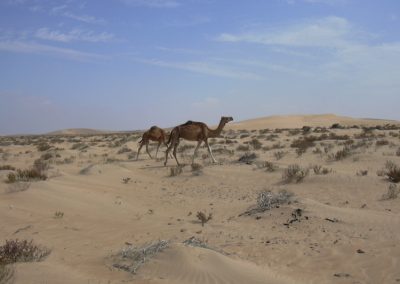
[112,240,169,274]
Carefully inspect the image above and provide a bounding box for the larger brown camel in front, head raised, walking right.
[164,116,233,166]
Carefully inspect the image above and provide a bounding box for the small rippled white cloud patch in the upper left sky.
[35,28,114,42]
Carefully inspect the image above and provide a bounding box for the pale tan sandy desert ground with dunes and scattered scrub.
[0,115,400,283]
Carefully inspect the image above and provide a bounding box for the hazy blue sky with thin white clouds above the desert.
[0,0,400,135]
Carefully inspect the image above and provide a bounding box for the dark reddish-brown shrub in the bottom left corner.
[0,239,50,265]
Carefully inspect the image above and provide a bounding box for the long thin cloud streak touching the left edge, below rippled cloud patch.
[0,40,105,61]
